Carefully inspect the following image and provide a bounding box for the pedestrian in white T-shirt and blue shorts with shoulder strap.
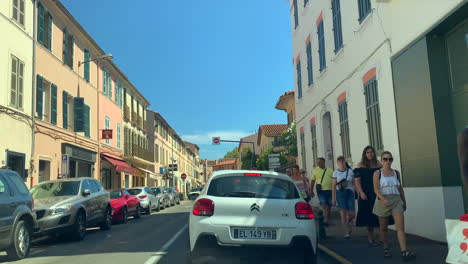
[332,156,355,239]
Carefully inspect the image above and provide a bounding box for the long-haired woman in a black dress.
[354,146,382,247]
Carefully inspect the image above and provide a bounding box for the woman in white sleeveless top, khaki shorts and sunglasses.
[374,151,416,261]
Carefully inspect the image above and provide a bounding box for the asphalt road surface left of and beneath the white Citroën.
[0,201,336,264]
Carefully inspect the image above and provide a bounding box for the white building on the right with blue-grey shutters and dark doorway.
[290,0,468,241]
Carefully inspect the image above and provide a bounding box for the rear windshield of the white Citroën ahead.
[207,175,299,199]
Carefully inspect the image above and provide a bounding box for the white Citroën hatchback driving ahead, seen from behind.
[189,170,317,263]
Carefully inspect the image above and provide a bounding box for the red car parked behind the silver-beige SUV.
[110,189,141,223]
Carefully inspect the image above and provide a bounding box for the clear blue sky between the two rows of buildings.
[62,0,293,159]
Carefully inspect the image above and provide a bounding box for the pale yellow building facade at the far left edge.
[0,0,35,186]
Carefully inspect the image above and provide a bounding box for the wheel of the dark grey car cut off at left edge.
[6,220,31,260]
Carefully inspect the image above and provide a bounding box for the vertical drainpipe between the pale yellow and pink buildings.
[29,0,37,188]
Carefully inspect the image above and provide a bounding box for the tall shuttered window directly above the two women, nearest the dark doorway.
[364,78,383,152]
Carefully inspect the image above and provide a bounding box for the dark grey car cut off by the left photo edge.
[0,170,36,260]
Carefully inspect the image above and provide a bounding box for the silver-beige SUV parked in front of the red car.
[30,177,112,240]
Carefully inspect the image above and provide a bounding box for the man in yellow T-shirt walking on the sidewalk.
[309,158,333,226]
